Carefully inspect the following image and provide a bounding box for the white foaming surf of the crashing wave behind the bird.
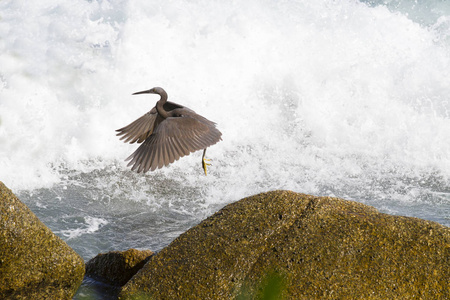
[0,0,450,211]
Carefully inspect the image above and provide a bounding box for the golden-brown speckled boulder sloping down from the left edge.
[0,182,84,299]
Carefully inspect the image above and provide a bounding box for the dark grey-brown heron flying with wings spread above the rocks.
[116,87,222,175]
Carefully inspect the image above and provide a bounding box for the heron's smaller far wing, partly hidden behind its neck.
[116,101,183,144]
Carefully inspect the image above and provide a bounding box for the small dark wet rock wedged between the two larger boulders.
[86,249,153,286]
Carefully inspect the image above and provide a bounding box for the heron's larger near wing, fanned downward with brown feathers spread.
[126,109,222,173]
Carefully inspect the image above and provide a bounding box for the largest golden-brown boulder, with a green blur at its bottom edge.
[119,191,450,299]
